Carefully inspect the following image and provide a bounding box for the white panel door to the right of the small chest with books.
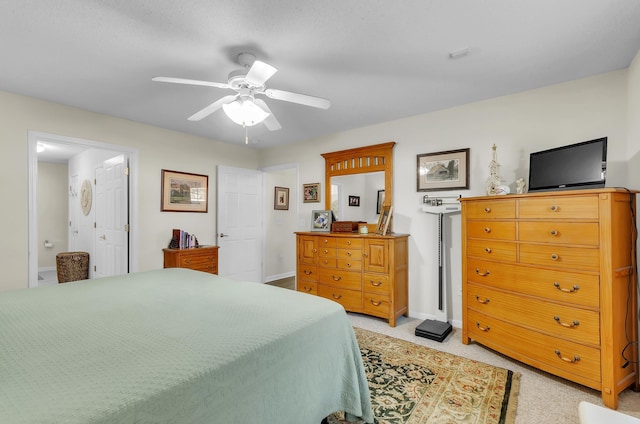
[217,166,264,283]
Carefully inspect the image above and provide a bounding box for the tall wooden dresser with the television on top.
[461,189,640,409]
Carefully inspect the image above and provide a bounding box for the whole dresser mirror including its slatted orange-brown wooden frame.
[322,141,396,226]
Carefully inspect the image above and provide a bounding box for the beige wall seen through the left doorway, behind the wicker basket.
[38,163,69,268]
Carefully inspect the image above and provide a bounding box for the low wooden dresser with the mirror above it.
[296,232,409,327]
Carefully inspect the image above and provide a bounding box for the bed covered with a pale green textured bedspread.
[0,268,373,424]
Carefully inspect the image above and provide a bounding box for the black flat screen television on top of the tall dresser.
[529,137,607,192]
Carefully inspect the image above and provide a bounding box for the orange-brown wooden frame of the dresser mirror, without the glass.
[322,141,396,220]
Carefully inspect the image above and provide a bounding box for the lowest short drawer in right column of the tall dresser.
[520,243,600,271]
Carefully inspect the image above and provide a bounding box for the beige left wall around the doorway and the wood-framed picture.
[0,92,258,290]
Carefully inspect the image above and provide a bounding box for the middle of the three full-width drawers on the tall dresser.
[467,284,600,346]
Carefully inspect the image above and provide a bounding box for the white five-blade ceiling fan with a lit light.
[152,53,331,131]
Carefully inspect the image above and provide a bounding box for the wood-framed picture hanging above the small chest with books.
[160,169,209,213]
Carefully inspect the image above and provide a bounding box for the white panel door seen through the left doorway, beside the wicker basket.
[93,155,129,278]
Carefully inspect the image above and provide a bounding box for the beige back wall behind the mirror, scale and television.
[261,70,640,323]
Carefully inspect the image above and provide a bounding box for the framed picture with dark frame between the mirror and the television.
[417,148,469,191]
